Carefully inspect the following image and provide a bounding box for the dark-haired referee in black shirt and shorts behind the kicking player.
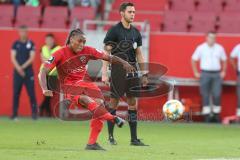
[102,2,148,146]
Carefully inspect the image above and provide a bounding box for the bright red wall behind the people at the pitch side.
[0,30,240,119]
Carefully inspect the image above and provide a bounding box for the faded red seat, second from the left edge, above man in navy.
[15,6,41,28]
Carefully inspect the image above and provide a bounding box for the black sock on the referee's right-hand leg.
[128,110,137,140]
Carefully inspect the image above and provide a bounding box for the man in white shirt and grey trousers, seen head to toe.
[192,32,227,118]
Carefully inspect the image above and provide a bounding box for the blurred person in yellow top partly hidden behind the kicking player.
[39,33,60,117]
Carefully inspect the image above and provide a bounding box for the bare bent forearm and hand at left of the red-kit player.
[38,67,53,96]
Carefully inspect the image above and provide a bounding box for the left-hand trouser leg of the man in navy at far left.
[11,73,23,119]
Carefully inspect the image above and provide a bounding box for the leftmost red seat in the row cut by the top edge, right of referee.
[170,0,195,12]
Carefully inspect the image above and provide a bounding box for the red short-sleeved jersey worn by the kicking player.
[44,46,104,84]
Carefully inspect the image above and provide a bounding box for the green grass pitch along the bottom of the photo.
[0,118,240,160]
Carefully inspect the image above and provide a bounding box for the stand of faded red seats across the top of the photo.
[0,0,240,33]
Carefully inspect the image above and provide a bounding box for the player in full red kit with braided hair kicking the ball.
[38,29,135,150]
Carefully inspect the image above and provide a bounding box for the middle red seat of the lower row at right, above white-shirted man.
[191,12,216,33]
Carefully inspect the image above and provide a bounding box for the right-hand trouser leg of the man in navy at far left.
[24,76,37,120]
